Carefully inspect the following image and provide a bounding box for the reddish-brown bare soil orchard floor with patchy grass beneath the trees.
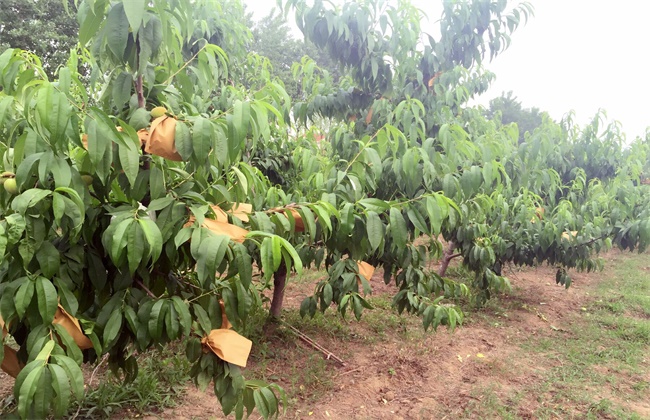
[0,252,650,419]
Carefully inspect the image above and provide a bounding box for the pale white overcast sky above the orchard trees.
[244,0,650,141]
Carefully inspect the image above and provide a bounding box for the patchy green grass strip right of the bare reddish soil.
[450,254,650,419]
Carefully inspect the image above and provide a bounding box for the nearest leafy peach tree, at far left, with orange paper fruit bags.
[0,0,301,417]
